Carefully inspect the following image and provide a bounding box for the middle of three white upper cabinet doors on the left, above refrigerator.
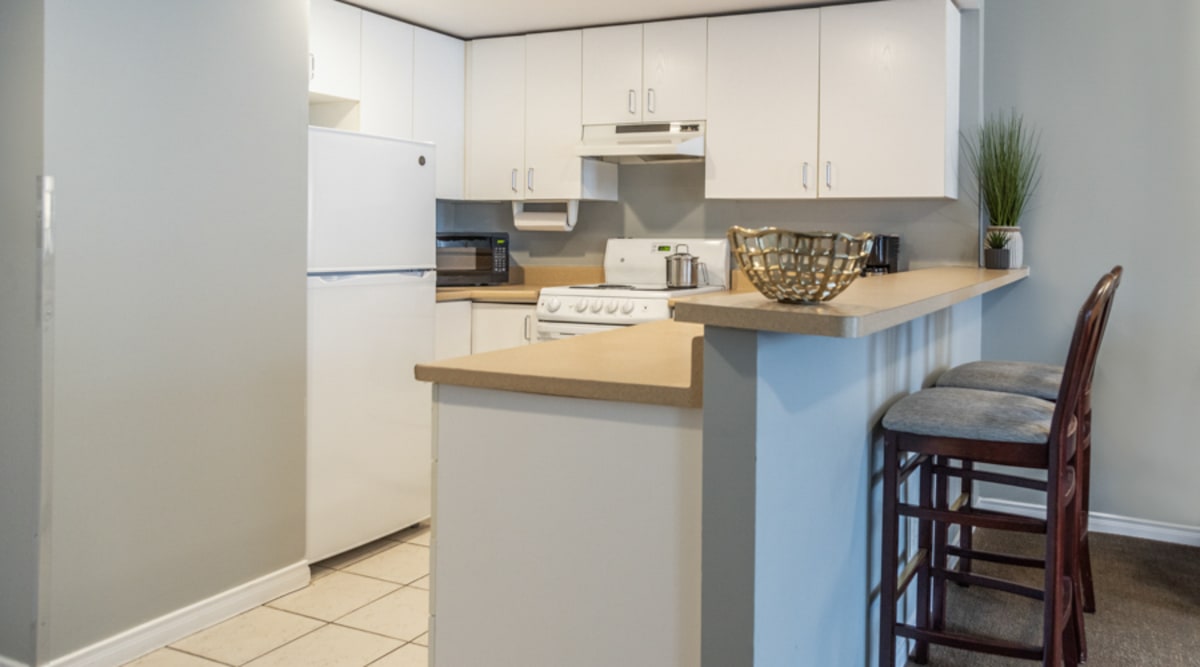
[359,12,413,139]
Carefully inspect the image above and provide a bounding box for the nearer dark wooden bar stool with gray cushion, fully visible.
[880,268,1116,667]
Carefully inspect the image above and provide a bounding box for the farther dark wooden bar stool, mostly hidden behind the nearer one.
[935,265,1123,613]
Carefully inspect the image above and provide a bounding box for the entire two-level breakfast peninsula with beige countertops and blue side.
[416,266,1028,667]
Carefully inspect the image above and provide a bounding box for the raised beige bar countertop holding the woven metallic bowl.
[674,266,1030,338]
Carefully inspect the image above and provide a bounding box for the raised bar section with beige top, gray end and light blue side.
[676,268,1027,667]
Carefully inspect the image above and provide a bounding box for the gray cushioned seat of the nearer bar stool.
[883,386,1054,444]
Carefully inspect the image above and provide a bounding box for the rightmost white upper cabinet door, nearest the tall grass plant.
[821,0,960,198]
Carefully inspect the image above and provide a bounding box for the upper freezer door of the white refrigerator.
[308,127,437,274]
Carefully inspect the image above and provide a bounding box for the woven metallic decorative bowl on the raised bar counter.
[728,227,875,304]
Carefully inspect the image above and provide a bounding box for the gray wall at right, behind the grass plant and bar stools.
[983,0,1200,528]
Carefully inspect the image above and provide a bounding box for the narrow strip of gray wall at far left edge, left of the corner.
[0,0,42,662]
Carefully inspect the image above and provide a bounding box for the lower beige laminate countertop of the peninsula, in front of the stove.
[416,320,704,408]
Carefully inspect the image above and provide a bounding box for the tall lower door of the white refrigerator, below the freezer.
[307,271,437,561]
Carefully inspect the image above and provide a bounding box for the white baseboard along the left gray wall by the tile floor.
[45,560,310,667]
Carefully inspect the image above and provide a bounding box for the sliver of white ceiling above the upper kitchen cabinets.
[349,0,862,40]
